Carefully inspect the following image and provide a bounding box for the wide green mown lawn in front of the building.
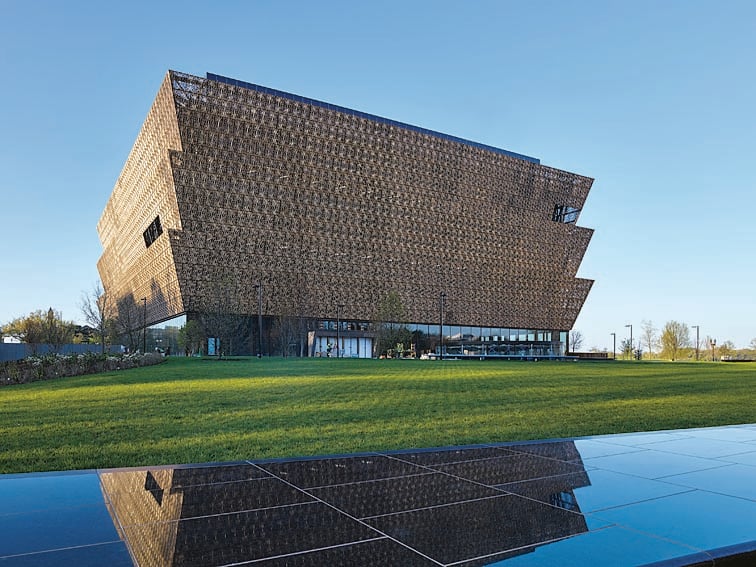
[0,358,756,473]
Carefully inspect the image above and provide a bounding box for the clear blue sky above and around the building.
[0,0,756,349]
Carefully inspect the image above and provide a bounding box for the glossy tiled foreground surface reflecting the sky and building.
[0,424,756,567]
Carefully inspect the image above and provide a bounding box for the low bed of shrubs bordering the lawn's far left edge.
[0,352,165,386]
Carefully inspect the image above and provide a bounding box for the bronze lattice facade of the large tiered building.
[98,71,593,356]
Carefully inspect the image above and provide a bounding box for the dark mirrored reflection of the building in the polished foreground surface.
[101,442,590,567]
